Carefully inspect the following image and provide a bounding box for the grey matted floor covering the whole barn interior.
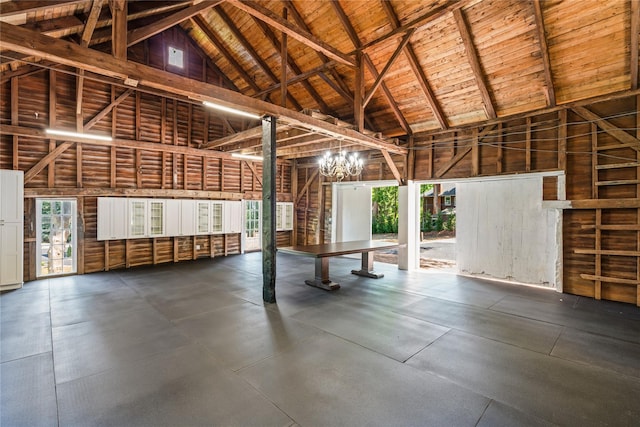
[0,253,640,427]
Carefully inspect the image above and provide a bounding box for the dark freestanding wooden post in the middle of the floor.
[262,116,277,303]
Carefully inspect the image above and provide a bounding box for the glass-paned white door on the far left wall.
[36,199,77,277]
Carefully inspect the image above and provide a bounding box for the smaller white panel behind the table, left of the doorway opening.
[331,183,371,242]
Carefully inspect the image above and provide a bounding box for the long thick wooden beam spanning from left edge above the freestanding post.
[0,22,407,154]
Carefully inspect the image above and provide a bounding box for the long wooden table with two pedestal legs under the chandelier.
[278,240,399,291]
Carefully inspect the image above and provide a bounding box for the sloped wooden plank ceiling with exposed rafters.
[0,0,640,158]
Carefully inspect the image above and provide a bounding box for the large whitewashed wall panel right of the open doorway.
[456,176,561,288]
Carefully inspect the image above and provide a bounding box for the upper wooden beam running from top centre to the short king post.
[227,0,355,67]
